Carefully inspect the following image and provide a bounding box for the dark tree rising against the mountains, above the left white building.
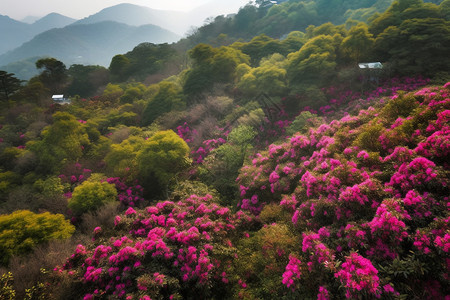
[36,58,69,94]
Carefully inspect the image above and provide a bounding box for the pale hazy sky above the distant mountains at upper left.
[0,0,248,20]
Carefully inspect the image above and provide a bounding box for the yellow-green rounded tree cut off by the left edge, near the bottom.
[0,210,75,266]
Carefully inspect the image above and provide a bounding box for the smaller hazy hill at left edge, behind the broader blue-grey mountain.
[0,13,76,54]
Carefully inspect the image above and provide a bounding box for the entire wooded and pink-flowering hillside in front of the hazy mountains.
[0,0,450,299]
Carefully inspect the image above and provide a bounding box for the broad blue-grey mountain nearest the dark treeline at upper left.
[0,21,180,66]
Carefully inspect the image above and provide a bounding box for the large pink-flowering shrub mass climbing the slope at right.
[237,85,450,299]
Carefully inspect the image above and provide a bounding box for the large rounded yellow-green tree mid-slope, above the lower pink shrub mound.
[137,130,190,197]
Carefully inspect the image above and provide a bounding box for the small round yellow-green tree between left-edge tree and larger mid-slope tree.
[68,174,117,215]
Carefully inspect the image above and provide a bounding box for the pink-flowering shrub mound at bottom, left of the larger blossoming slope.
[55,195,252,299]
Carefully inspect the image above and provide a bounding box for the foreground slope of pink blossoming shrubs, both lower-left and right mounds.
[51,83,450,299]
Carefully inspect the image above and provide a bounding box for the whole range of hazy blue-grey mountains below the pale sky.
[0,0,246,79]
